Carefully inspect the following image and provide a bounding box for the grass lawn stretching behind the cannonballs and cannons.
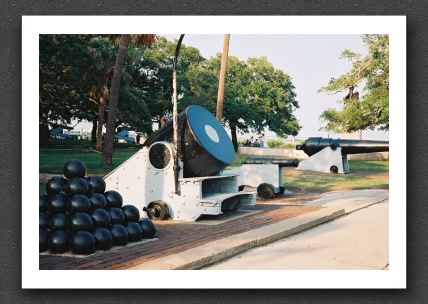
[39,145,389,192]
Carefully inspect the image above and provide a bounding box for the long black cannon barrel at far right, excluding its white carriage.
[296,137,389,156]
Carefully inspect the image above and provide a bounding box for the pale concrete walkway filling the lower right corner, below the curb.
[205,201,389,270]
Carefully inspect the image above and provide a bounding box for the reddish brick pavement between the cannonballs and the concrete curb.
[39,195,323,270]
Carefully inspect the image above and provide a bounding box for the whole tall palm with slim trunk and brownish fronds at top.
[99,34,156,166]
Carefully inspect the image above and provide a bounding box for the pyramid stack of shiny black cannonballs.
[39,160,156,254]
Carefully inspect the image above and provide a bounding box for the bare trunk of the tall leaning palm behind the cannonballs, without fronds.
[103,34,130,166]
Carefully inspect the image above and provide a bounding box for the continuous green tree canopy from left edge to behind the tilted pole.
[40,35,300,150]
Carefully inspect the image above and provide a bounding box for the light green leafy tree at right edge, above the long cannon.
[319,35,389,133]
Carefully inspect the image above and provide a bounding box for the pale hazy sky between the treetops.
[165,35,388,140]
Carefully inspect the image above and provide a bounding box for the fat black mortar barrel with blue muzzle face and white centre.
[144,105,235,177]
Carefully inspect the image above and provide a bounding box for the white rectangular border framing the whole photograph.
[22,16,407,289]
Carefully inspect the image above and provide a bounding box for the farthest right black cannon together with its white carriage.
[296,137,389,173]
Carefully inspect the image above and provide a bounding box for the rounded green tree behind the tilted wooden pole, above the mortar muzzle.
[180,54,300,149]
